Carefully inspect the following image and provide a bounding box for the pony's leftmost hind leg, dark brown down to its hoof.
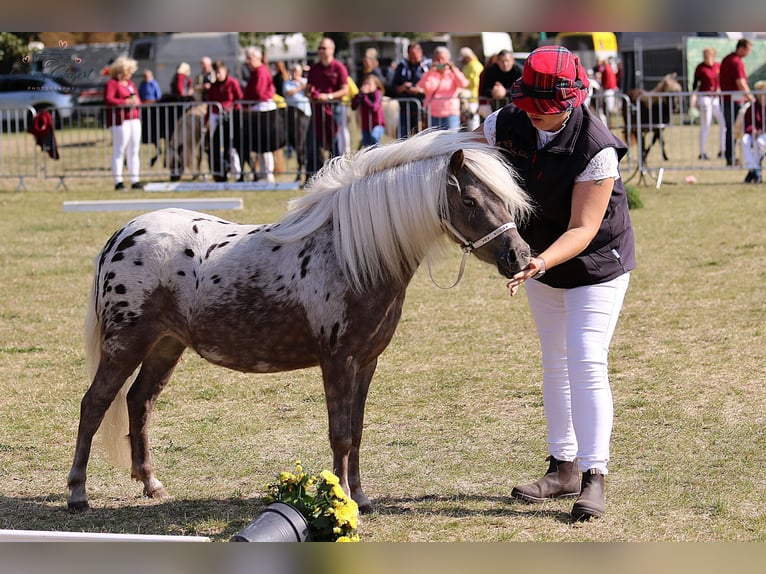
[67,360,144,510]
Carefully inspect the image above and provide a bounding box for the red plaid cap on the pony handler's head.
[511,46,589,114]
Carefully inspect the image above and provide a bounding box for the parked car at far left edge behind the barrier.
[0,74,76,127]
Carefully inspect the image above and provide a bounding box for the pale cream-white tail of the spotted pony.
[85,281,133,468]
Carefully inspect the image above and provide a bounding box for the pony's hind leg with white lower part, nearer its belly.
[127,337,186,498]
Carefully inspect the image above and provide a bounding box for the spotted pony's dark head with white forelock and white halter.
[445,150,530,277]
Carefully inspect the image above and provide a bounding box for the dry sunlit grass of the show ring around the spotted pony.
[0,173,766,542]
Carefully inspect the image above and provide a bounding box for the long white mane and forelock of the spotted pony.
[269,130,530,289]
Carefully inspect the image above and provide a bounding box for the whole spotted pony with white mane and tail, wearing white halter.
[68,131,530,511]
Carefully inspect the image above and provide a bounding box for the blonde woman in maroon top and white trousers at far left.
[104,56,144,190]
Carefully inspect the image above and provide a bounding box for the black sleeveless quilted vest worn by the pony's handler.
[496,104,636,289]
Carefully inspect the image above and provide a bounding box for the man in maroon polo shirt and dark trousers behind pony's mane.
[306,37,348,184]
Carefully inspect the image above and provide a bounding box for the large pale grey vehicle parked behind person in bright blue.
[130,32,245,94]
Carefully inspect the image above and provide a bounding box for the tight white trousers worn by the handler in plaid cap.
[524,273,630,474]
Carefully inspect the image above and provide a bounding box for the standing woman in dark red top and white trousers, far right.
[690,47,726,159]
